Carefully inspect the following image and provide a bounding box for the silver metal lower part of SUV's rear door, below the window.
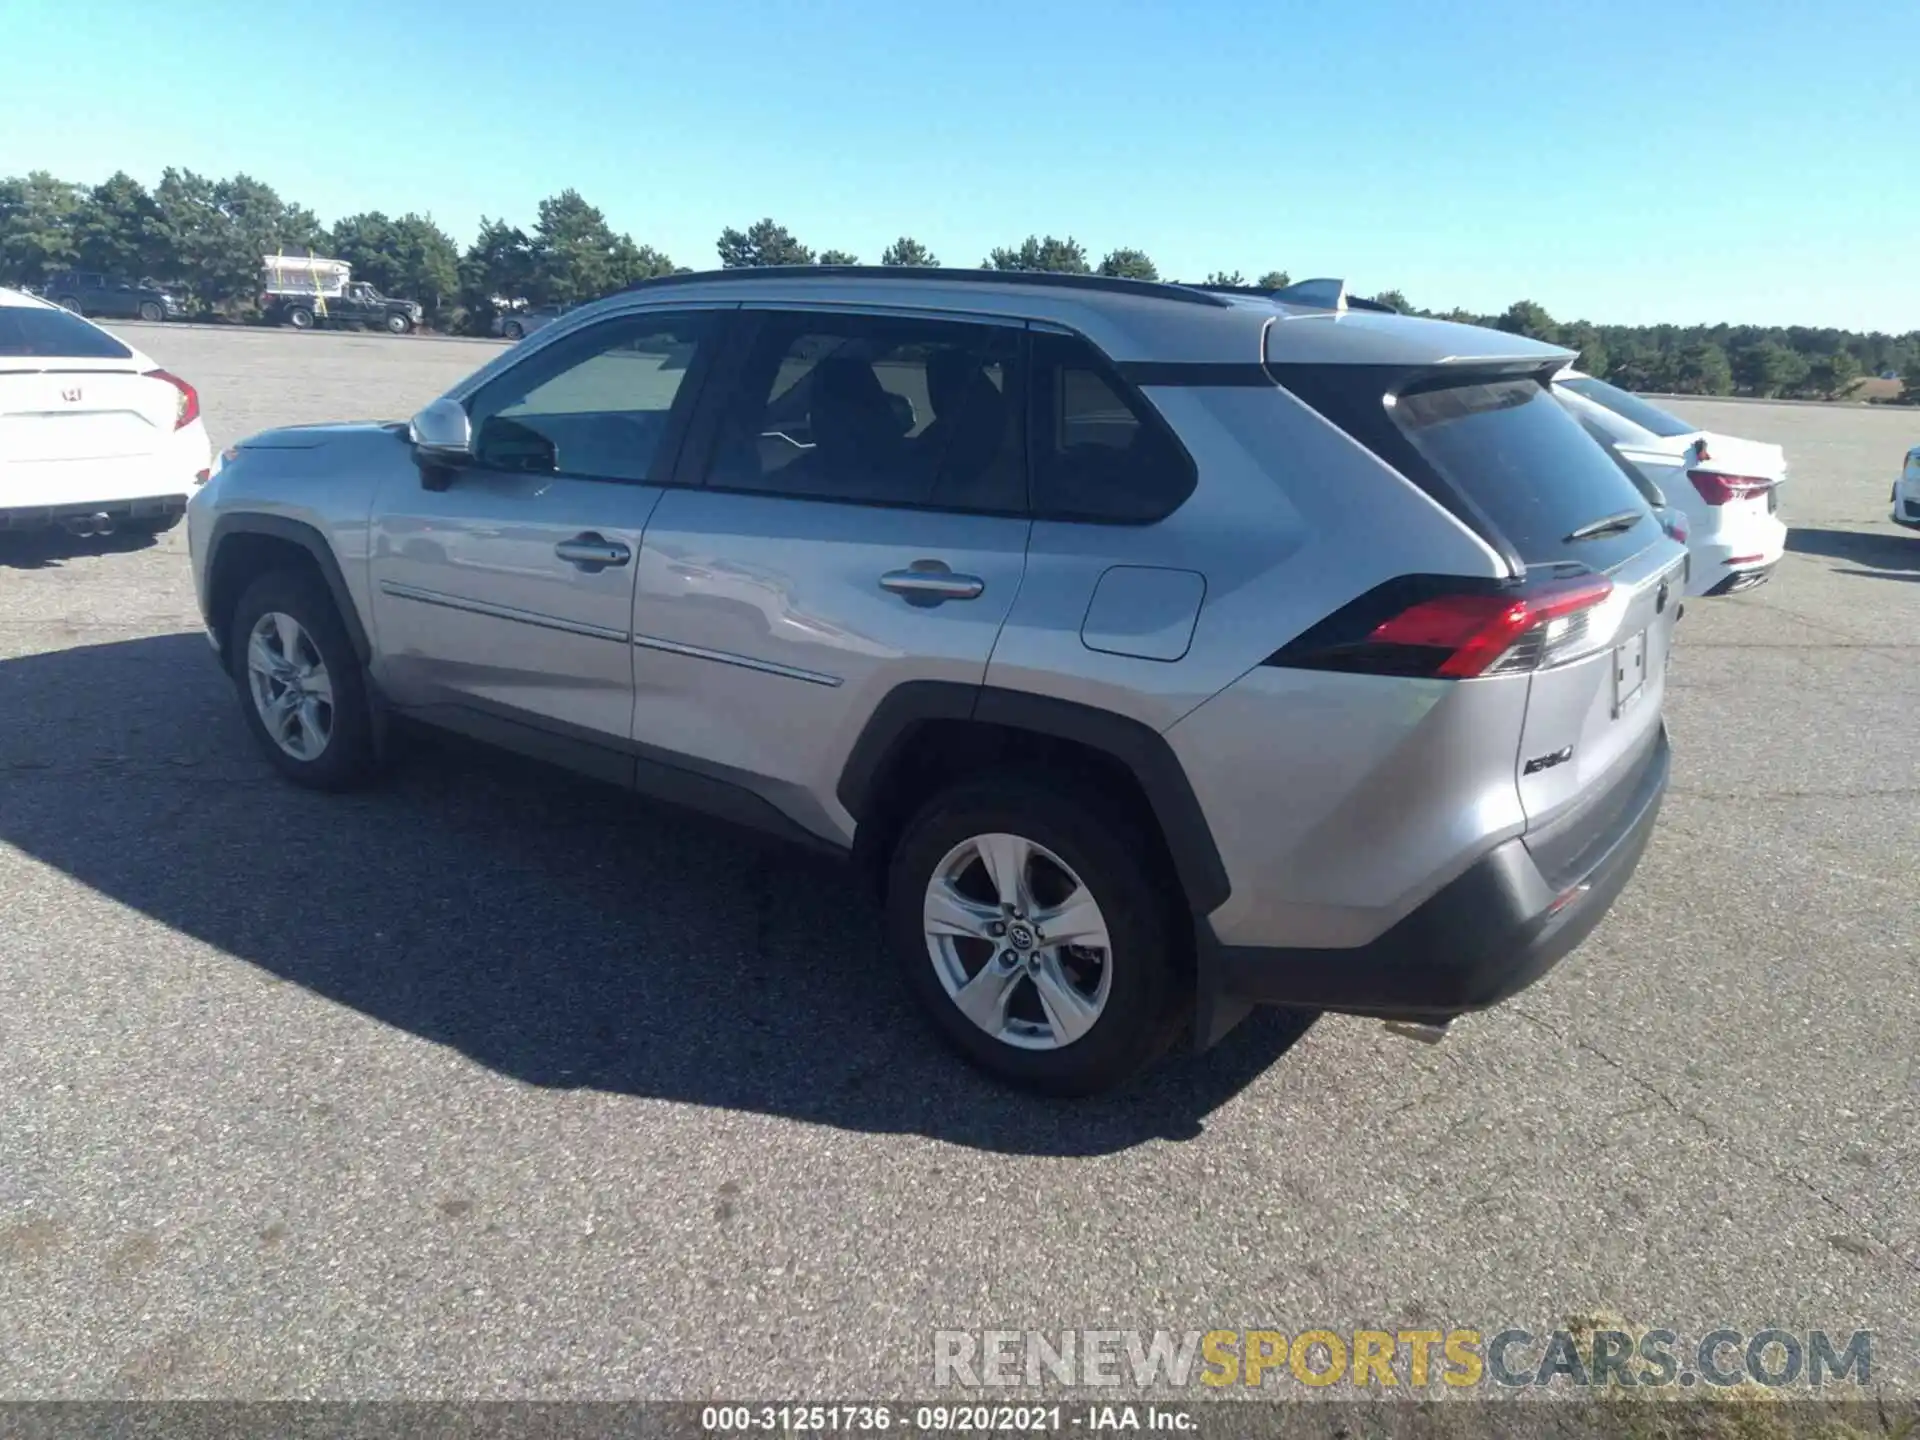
[632,490,1029,829]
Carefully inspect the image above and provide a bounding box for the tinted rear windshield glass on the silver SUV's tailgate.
[1392,378,1657,570]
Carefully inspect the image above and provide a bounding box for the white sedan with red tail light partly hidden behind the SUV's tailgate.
[1553,371,1788,595]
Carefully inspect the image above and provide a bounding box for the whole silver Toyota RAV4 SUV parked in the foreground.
[190,269,1686,1092]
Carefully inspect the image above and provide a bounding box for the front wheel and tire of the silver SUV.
[227,570,374,789]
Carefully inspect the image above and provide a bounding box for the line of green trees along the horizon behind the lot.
[0,167,1920,403]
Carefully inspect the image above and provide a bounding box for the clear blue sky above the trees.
[0,0,1920,330]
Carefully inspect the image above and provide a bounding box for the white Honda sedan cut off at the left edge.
[0,288,213,534]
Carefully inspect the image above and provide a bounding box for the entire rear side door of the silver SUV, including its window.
[632,305,1031,841]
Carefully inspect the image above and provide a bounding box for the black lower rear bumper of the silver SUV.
[1196,726,1672,1046]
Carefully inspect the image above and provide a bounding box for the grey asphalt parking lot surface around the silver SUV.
[0,326,1920,1398]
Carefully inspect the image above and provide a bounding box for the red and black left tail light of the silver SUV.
[1267,574,1613,680]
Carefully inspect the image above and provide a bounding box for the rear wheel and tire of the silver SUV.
[887,774,1185,1096]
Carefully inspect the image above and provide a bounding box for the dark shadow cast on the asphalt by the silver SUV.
[0,636,1306,1154]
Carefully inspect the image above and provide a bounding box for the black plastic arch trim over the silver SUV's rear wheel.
[835,680,1233,916]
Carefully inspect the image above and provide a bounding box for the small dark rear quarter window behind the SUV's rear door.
[1033,334,1196,524]
